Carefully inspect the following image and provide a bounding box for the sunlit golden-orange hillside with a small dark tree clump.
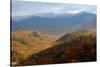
[11,31,56,64]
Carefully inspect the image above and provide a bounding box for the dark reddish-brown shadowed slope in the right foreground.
[16,31,96,66]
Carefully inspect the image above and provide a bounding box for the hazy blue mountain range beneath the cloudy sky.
[12,11,96,35]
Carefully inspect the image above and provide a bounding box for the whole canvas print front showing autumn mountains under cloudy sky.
[11,0,96,66]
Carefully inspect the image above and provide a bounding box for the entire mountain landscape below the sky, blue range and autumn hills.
[11,11,96,65]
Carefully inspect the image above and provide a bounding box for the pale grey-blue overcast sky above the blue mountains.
[12,0,96,17]
